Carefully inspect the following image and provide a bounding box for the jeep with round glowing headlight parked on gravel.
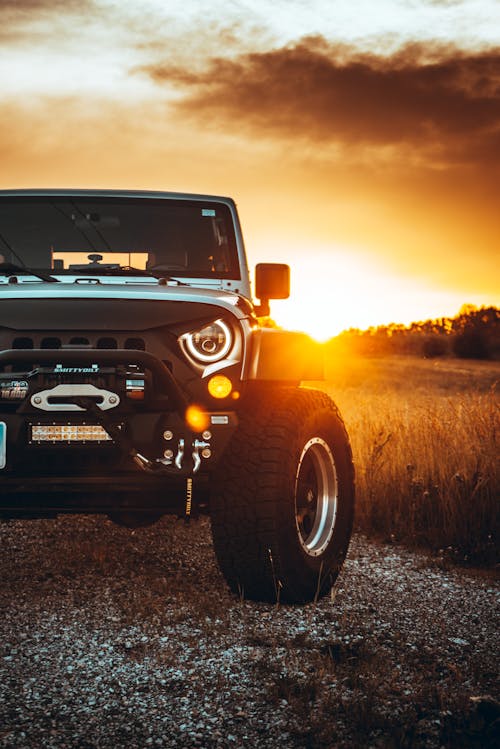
[0,190,354,602]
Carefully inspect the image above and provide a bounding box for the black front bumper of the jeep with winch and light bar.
[0,349,237,516]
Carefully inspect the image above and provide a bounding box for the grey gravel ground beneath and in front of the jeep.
[0,517,500,749]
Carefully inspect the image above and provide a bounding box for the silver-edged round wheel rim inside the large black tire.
[295,437,338,557]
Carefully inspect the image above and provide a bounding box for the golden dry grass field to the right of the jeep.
[315,352,500,563]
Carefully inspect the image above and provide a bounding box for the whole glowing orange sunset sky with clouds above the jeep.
[0,0,500,339]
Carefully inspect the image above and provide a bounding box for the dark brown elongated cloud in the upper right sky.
[141,36,500,166]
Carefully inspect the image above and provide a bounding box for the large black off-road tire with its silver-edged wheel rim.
[210,387,354,603]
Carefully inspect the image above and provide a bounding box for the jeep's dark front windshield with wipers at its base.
[0,195,240,278]
